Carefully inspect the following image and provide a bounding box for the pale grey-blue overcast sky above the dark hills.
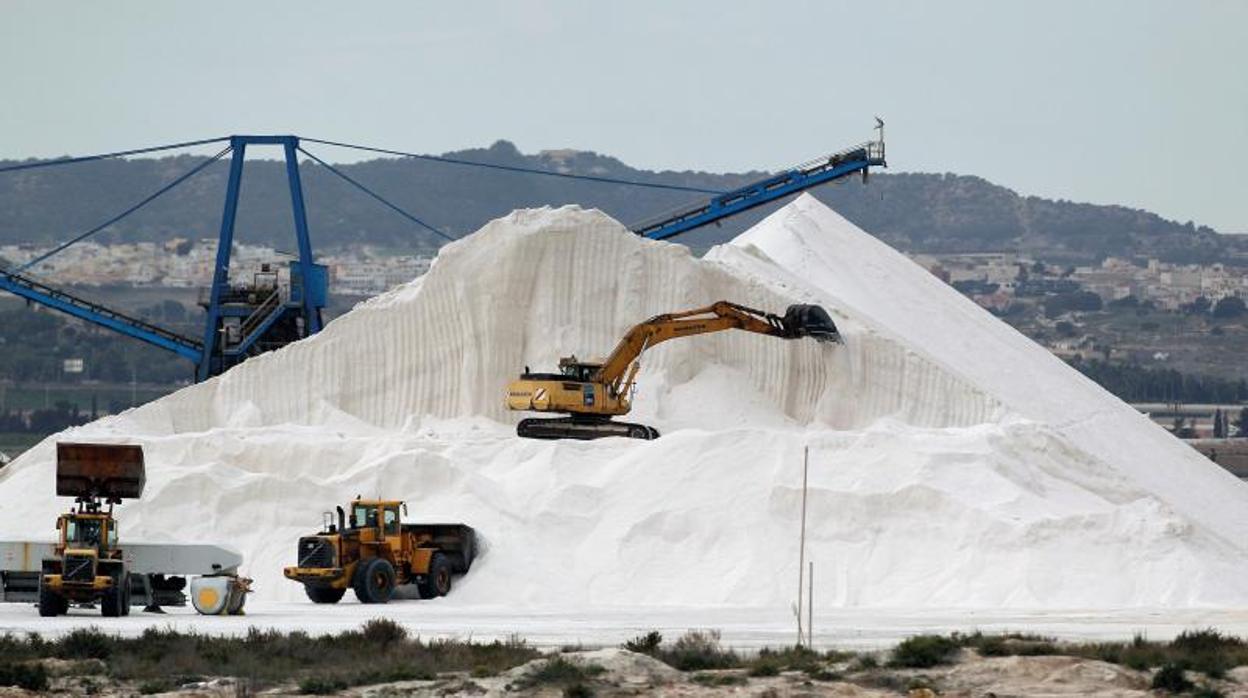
[0,0,1248,232]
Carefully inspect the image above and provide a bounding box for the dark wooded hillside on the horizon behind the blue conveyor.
[0,141,1246,263]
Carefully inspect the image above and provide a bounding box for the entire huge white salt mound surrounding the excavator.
[0,197,1248,614]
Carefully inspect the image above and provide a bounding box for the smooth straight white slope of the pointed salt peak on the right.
[710,196,1248,559]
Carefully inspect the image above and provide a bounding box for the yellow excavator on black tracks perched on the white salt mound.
[507,301,841,440]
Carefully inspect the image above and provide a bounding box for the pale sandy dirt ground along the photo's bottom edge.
[0,649,1248,698]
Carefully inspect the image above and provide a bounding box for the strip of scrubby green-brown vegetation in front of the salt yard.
[0,621,1248,697]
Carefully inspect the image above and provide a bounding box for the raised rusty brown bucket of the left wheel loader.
[56,443,146,499]
